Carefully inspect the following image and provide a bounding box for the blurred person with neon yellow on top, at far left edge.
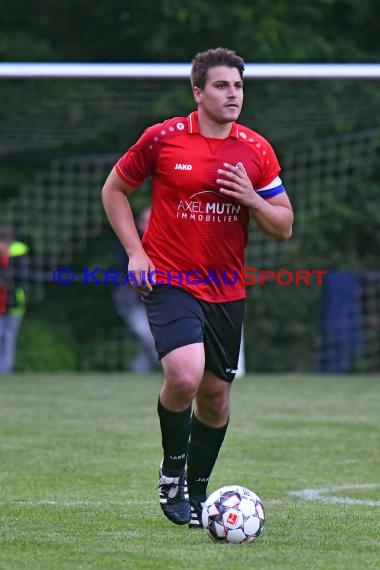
[0,225,29,374]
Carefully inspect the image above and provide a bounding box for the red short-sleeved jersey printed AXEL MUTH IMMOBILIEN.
[115,108,283,303]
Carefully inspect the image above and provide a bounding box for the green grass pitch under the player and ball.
[0,374,380,570]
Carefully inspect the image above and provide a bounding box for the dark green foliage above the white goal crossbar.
[0,0,380,62]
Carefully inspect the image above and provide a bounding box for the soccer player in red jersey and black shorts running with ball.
[102,48,293,528]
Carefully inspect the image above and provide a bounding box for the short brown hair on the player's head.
[190,47,244,89]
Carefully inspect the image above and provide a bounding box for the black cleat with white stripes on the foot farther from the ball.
[158,463,191,524]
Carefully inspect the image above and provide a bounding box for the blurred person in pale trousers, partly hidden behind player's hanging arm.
[113,207,158,374]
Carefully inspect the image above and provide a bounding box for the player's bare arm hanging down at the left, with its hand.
[102,168,154,293]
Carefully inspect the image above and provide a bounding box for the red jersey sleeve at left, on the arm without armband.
[115,125,160,187]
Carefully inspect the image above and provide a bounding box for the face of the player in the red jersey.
[194,66,243,124]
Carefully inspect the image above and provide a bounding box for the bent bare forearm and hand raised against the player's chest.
[217,163,294,240]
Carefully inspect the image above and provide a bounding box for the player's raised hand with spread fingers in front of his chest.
[216,162,261,208]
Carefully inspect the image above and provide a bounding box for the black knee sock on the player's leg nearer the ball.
[187,414,228,498]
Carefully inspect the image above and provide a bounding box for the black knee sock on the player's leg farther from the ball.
[157,399,191,475]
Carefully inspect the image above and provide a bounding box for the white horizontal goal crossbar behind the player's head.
[0,62,380,79]
